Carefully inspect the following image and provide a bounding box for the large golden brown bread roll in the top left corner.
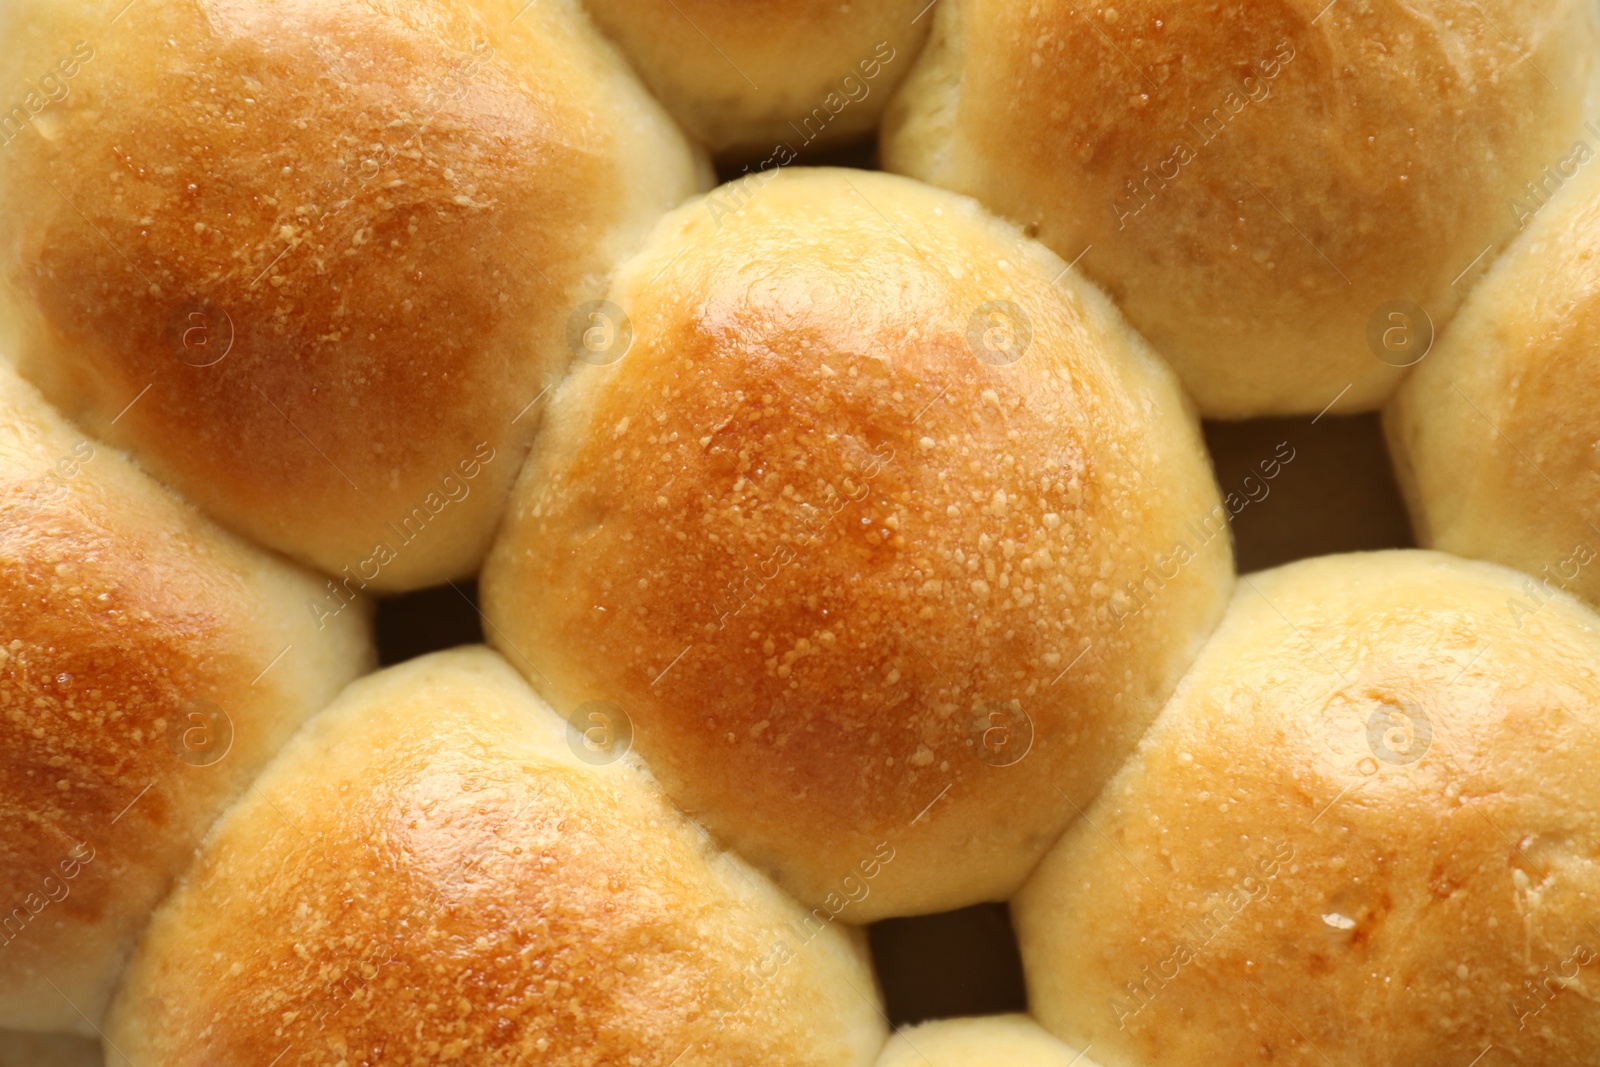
[0,0,696,591]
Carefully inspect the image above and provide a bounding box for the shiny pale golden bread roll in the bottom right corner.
[1013,550,1600,1067]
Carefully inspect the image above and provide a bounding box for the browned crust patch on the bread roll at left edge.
[0,483,233,991]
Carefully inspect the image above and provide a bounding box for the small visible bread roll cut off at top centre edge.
[586,0,933,166]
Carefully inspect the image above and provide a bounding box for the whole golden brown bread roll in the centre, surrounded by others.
[480,170,1232,923]
